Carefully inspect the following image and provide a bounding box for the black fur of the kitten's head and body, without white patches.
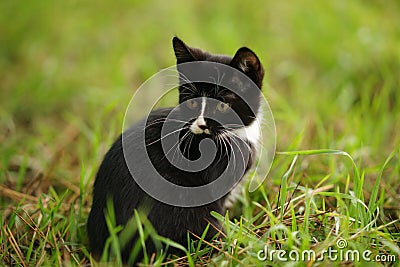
[87,37,264,263]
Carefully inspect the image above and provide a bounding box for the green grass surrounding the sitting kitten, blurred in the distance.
[0,0,400,266]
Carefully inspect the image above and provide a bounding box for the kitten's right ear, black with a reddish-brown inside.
[230,47,264,89]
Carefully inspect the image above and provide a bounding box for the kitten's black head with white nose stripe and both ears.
[173,37,264,140]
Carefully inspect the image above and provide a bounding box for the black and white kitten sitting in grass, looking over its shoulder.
[87,37,264,263]
